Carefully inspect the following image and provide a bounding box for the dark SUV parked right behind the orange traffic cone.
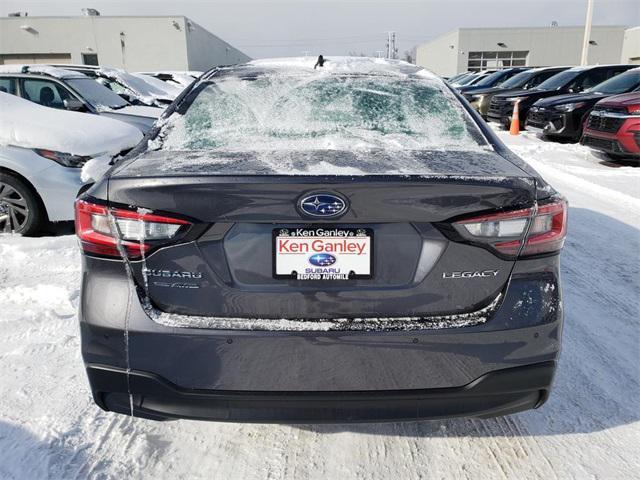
[487,65,637,128]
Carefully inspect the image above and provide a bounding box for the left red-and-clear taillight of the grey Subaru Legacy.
[76,200,191,258]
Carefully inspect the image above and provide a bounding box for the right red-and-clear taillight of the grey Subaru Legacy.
[453,200,567,256]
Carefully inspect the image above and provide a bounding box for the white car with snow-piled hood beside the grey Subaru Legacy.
[0,93,142,235]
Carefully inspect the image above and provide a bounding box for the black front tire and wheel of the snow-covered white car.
[0,172,48,236]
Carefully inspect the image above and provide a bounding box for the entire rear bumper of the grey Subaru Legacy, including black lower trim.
[80,256,562,422]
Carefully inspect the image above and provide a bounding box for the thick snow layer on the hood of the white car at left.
[0,92,142,156]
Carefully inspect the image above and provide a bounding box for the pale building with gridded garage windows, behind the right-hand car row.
[416,26,640,76]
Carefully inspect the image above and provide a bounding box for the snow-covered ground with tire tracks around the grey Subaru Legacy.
[0,128,640,480]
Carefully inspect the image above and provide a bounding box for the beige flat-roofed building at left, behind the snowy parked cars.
[0,9,250,71]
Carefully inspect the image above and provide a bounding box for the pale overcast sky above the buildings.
[0,0,640,58]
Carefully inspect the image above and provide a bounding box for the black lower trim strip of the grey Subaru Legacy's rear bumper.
[87,361,556,424]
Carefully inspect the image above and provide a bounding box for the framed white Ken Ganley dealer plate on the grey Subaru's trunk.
[273,227,373,280]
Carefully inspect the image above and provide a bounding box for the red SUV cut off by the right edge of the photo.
[580,92,640,159]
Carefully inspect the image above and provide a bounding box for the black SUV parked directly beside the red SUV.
[525,68,640,142]
